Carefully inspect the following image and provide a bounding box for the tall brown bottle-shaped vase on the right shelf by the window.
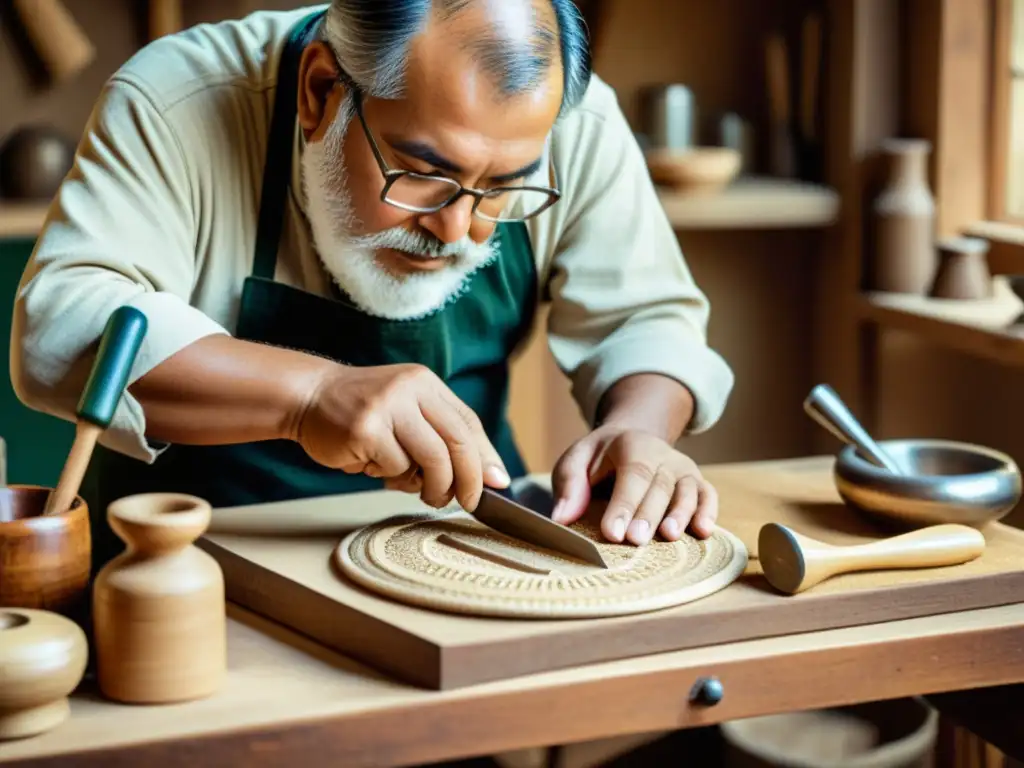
[872,138,937,296]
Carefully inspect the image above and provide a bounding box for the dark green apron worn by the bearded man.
[83,6,538,569]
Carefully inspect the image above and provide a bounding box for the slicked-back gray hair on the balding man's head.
[322,0,591,114]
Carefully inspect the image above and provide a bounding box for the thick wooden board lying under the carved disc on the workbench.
[201,466,1024,689]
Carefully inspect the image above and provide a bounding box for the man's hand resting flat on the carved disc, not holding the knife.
[552,426,718,545]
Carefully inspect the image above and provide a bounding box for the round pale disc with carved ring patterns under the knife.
[335,510,748,618]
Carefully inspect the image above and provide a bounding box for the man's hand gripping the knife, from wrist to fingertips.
[296,365,509,511]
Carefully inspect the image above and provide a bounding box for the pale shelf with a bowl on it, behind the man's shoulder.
[658,177,839,229]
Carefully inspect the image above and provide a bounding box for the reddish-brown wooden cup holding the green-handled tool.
[0,485,92,616]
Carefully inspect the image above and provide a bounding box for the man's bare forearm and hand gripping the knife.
[130,334,509,512]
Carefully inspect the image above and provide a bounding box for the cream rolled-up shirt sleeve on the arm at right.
[548,84,734,434]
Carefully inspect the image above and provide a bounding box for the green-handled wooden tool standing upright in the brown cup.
[43,306,146,515]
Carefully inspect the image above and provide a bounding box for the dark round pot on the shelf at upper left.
[0,125,75,200]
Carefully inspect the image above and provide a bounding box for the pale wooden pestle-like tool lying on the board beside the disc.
[758,523,985,594]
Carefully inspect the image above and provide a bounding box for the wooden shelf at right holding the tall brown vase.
[860,280,1024,367]
